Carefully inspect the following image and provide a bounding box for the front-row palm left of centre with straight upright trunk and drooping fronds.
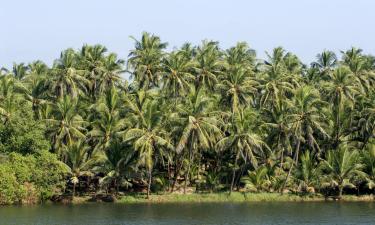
[125,101,173,198]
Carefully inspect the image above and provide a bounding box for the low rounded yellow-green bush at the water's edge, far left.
[0,151,67,204]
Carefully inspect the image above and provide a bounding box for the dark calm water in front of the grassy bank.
[0,202,375,225]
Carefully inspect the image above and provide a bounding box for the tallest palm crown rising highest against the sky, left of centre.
[128,32,167,89]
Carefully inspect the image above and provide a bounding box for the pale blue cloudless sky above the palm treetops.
[0,0,375,68]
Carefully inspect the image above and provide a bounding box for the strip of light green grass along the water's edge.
[68,192,375,204]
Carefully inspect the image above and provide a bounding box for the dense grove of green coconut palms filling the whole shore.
[0,33,375,204]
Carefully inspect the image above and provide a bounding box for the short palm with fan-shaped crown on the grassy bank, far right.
[321,145,366,199]
